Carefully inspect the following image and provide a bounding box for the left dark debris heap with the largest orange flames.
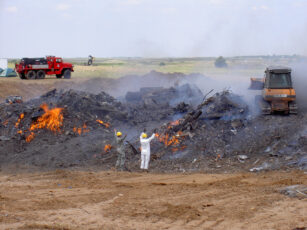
[0,84,202,167]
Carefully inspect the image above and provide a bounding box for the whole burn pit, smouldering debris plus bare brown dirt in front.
[0,71,307,229]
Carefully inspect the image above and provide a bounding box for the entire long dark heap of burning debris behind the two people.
[0,84,305,171]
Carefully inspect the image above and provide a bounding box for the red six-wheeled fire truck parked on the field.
[15,56,74,79]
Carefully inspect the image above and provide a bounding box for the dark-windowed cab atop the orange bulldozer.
[264,67,292,89]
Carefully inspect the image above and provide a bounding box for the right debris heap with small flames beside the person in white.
[135,91,248,162]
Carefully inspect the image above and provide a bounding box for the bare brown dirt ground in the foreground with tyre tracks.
[0,170,307,230]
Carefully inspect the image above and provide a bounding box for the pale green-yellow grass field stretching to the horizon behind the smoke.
[9,56,297,78]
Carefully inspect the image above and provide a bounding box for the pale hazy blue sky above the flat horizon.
[0,0,307,57]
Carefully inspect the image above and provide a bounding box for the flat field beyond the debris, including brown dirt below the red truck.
[0,56,296,99]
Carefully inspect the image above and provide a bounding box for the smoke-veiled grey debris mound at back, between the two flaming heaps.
[125,84,203,123]
